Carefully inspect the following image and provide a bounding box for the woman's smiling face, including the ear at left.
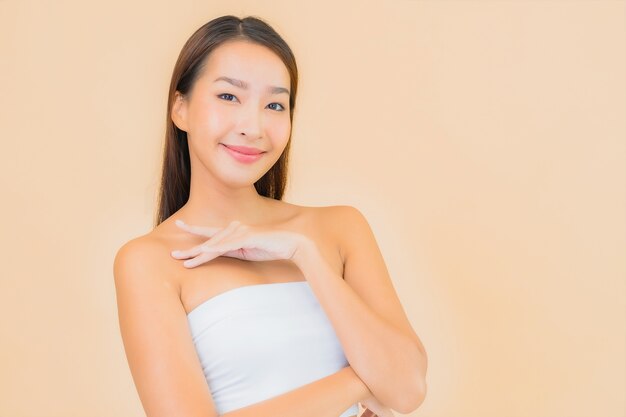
[172,40,291,187]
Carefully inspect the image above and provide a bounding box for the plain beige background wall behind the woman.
[0,0,626,417]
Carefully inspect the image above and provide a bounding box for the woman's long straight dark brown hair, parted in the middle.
[154,15,298,227]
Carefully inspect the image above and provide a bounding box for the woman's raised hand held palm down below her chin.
[171,220,305,268]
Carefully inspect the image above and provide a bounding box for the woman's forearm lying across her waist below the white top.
[221,366,372,417]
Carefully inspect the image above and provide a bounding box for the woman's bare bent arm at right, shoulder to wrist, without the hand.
[292,206,427,413]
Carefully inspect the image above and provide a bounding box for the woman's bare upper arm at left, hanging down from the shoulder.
[114,235,217,417]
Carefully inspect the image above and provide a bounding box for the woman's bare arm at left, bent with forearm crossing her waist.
[113,238,372,417]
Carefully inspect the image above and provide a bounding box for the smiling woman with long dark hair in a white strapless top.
[114,16,426,417]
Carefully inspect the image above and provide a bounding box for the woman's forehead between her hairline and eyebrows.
[197,40,289,89]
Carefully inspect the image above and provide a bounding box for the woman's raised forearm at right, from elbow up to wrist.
[294,239,425,413]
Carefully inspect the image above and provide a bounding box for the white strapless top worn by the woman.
[187,281,358,417]
